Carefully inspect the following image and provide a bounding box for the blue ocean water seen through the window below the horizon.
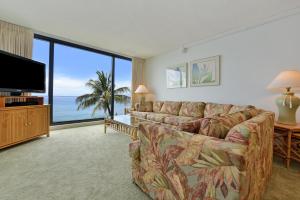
[45,96,130,122]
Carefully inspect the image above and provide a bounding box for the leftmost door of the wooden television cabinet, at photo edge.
[0,111,12,147]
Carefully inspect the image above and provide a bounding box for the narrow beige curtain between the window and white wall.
[131,58,145,107]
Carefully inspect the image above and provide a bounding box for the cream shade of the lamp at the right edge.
[267,70,300,90]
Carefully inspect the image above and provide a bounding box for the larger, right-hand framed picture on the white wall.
[189,56,220,87]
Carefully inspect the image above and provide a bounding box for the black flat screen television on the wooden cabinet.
[0,51,46,93]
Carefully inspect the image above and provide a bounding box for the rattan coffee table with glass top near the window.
[104,115,141,141]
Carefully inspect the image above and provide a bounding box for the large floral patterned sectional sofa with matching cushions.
[129,102,274,200]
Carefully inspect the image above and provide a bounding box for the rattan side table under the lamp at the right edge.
[274,122,300,168]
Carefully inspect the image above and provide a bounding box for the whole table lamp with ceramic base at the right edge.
[268,70,300,125]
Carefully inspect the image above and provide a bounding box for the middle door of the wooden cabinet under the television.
[7,109,27,142]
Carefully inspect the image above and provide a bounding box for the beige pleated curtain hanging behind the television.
[0,20,33,96]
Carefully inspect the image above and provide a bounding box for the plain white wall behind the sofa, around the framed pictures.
[145,15,300,121]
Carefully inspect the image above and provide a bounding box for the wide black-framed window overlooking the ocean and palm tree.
[33,35,131,124]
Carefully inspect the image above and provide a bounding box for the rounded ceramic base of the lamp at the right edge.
[276,92,300,125]
